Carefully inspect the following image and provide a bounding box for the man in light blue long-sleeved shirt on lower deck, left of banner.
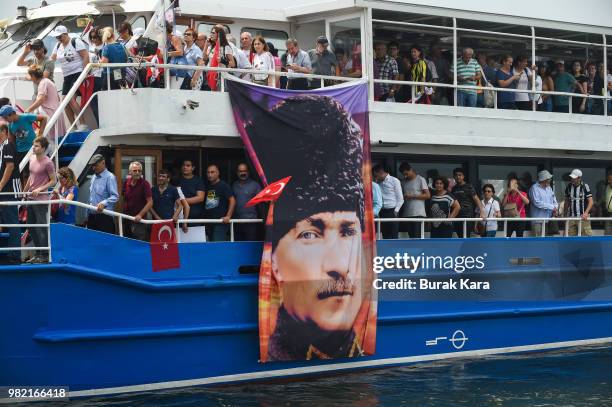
[87,154,119,233]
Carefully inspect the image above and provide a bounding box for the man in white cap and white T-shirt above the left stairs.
[49,25,89,125]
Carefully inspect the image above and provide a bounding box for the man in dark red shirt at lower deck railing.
[123,161,153,241]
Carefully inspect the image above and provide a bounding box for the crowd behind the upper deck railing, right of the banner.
[374,41,612,115]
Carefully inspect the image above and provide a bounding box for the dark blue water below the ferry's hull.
[64,347,612,407]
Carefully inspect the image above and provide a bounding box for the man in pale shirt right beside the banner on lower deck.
[372,164,404,239]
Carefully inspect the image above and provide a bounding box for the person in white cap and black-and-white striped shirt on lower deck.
[564,168,593,236]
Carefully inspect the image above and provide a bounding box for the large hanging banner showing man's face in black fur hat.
[227,80,376,362]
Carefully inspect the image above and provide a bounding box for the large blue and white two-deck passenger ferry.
[0,0,612,397]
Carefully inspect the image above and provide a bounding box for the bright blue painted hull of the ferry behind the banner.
[0,224,612,396]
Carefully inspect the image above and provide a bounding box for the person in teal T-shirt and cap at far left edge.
[0,105,48,168]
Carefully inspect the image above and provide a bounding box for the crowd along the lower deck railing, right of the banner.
[372,163,612,239]
